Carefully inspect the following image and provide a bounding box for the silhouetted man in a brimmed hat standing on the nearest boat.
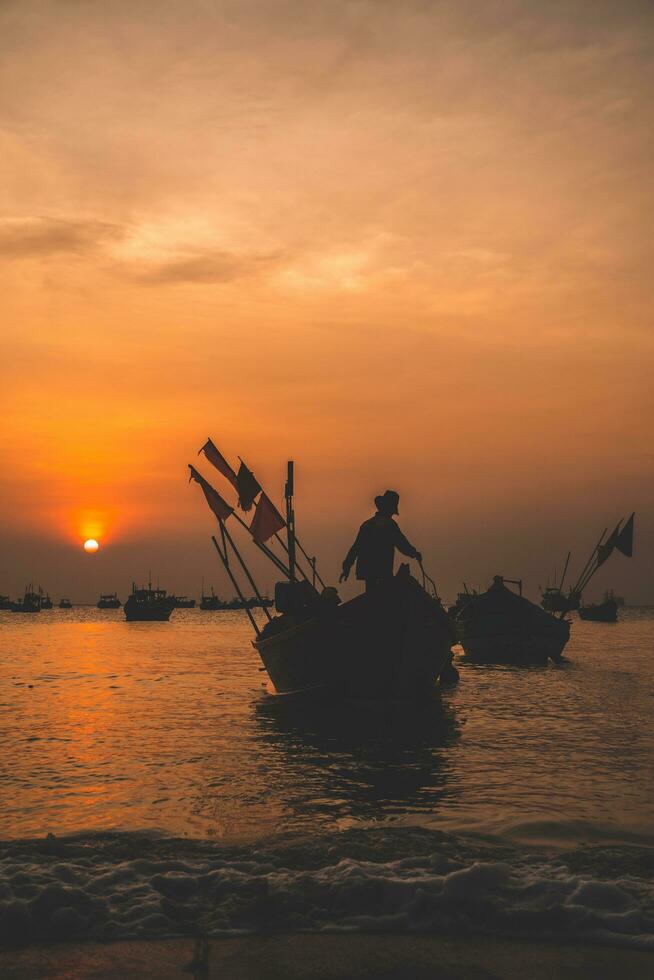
[339,490,422,592]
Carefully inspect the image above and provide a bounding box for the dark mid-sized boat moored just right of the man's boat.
[457,575,570,665]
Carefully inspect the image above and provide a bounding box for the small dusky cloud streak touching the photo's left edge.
[0,218,123,259]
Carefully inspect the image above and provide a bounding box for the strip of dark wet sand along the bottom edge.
[0,933,654,980]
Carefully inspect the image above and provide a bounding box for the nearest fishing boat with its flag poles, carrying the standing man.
[190,454,458,703]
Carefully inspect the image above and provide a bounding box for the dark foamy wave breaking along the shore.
[0,828,654,949]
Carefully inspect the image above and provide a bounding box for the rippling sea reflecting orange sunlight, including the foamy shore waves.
[0,607,654,949]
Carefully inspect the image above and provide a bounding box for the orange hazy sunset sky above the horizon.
[0,0,654,602]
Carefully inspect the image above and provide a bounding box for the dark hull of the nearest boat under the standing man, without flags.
[254,574,455,700]
